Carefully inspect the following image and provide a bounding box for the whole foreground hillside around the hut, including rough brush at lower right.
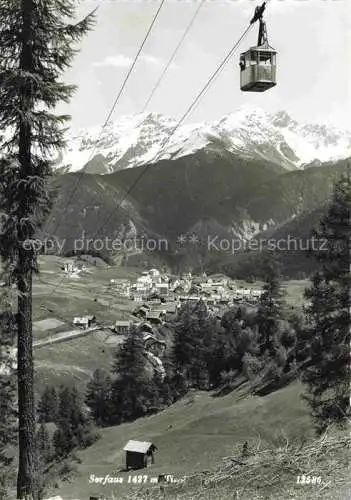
[51,382,349,500]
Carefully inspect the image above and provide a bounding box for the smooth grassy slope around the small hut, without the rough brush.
[54,383,313,499]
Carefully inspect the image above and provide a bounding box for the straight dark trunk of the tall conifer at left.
[17,0,38,500]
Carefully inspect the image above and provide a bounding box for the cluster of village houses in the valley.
[55,260,262,377]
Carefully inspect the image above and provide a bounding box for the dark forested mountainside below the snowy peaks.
[38,150,348,278]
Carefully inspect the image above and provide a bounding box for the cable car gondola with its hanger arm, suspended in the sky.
[240,2,277,92]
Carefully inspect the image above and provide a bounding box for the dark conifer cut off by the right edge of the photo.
[302,168,351,431]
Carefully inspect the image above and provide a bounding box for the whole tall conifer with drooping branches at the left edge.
[0,0,93,499]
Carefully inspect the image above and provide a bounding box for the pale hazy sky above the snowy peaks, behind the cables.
[60,0,351,133]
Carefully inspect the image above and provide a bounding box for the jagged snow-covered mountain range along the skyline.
[57,107,351,173]
